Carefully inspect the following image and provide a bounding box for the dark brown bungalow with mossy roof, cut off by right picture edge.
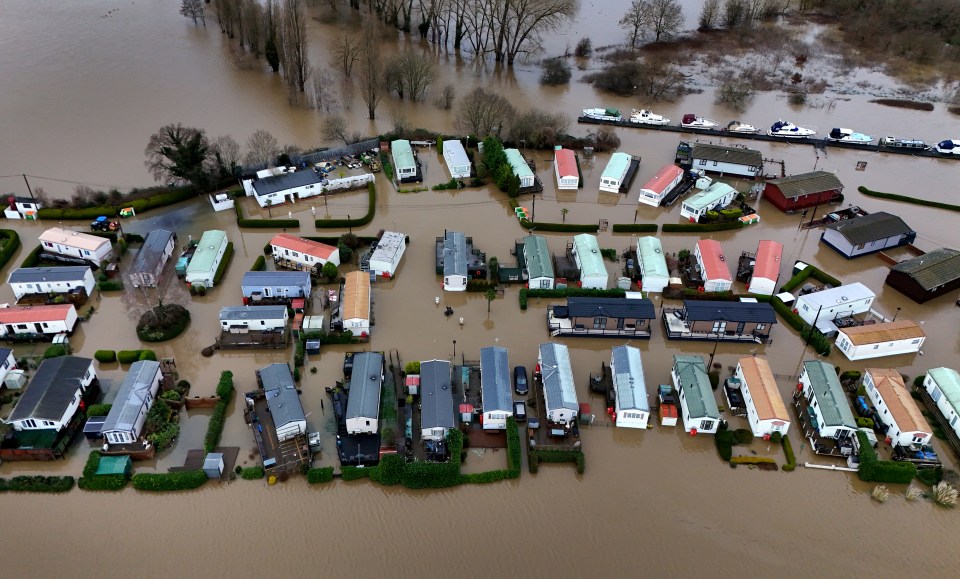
[886,247,960,304]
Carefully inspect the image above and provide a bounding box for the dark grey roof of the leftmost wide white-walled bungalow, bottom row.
[7,356,93,422]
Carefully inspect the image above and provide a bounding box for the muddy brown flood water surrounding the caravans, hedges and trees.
[0,0,960,577]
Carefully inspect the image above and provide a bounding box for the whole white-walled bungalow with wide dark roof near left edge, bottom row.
[4,356,97,432]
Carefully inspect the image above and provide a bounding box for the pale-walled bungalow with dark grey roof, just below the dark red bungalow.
[820,211,917,259]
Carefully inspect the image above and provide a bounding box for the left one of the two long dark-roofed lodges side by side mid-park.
[547,297,656,339]
